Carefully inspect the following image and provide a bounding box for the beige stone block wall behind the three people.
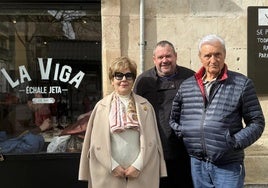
[101,0,268,184]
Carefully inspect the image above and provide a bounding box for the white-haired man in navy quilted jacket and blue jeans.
[170,35,265,188]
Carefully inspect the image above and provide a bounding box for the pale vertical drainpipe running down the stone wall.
[140,0,145,73]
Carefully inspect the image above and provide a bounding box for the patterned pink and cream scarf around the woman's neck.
[109,95,139,133]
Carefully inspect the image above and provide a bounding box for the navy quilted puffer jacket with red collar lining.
[170,66,265,164]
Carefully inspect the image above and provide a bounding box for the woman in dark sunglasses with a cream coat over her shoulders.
[79,57,166,188]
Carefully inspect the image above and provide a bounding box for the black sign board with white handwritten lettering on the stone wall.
[247,6,268,94]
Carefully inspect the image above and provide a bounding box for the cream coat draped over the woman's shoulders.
[79,93,167,188]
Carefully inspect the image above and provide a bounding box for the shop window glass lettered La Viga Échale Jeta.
[0,5,102,154]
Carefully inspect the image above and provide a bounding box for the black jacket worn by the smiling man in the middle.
[134,66,194,160]
